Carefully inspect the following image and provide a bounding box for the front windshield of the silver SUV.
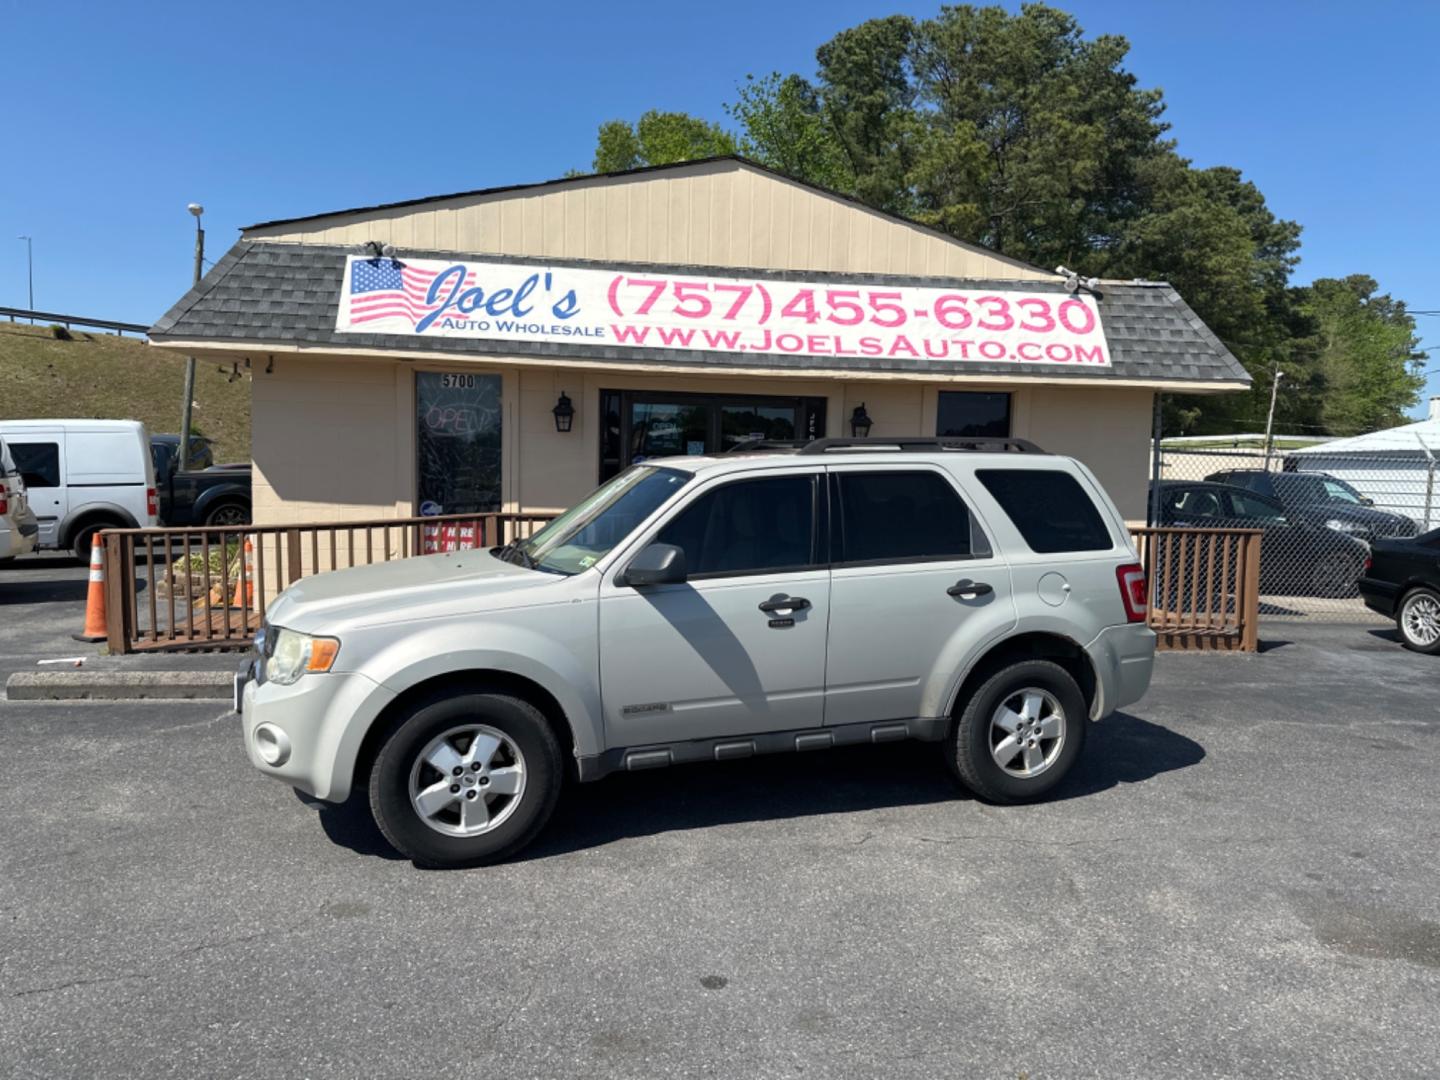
[517,465,691,573]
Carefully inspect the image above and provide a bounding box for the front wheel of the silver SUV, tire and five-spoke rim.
[370,691,563,867]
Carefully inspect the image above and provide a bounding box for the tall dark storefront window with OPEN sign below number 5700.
[415,372,501,517]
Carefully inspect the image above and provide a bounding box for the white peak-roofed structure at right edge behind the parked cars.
[1284,397,1440,531]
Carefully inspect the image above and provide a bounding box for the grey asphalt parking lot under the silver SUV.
[0,567,1440,1079]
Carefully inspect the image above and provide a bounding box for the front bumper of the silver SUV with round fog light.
[235,661,395,802]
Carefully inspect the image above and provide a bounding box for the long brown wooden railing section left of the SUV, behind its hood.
[102,514,554,652]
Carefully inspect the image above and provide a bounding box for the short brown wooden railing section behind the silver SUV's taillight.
[1130,528,1261,652]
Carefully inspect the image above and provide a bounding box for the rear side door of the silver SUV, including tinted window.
[825,465,1015,726]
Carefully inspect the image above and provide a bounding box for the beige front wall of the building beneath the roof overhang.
[244,357,1152,524]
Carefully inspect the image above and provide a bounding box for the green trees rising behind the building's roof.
[578,3,1420,435]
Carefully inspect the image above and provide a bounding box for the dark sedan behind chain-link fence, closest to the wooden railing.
[1156,480,1369,596]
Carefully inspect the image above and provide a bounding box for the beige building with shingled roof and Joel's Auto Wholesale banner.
[150,157,1248,523]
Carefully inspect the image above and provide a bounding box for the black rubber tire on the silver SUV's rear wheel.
[945,660,1090,804]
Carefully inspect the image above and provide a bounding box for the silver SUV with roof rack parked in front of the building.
[236,438,1155,867]
